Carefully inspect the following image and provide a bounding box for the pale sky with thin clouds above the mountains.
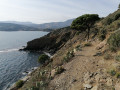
[0,0,120,24]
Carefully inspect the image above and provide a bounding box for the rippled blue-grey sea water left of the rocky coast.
[0,31,48,90]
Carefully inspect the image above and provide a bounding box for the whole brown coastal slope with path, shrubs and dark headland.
[10,9,120,90]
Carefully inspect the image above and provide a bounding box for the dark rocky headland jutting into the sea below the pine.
[24,27,76,53]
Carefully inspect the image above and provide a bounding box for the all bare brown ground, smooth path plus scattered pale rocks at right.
[49,42,120,90]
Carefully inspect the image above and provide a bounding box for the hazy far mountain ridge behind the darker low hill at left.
[0,19,74,31]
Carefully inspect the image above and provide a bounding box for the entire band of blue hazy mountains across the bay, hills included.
[0,19,74,32]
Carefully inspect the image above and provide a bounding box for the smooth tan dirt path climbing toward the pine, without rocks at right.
[50,41,108,90]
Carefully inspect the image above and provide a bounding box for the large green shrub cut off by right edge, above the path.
[107,30,120,51]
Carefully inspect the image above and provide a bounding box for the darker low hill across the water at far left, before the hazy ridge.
[0,23,40,31]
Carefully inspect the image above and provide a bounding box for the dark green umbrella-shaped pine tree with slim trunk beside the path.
[71,14,100,39]
